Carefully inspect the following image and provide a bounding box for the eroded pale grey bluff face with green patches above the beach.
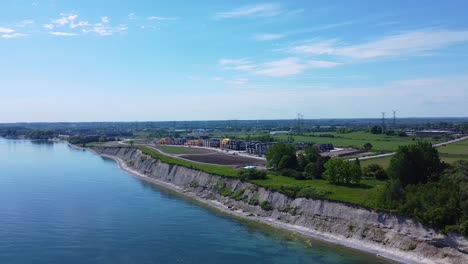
[93,148,468,263]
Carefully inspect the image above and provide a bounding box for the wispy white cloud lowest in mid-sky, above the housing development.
[219,57,341,77]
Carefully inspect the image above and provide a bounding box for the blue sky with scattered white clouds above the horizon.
[0,0,468,122]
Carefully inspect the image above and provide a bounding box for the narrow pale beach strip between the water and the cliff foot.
[88,150,435,263]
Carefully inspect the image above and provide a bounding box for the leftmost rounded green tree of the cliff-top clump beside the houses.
[265,143,297,170]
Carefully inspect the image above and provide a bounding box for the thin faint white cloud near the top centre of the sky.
[214,4,283,19]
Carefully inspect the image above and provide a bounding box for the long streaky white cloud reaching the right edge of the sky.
[290,30,468,59]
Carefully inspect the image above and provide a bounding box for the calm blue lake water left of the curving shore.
[0,139,392,263]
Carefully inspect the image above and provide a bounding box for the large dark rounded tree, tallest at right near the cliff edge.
[388,142,444,186]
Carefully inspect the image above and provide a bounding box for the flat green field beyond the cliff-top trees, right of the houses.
[275,132,432,152]
